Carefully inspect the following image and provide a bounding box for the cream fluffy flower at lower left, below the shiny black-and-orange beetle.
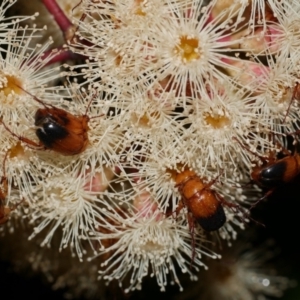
[28,168,125,259]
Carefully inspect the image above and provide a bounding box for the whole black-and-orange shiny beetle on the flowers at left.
[0,86,103,156]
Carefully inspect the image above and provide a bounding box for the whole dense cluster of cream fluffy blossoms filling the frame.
[0,0,300,299]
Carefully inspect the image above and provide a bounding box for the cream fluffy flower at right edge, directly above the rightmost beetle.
[253,54,300,133]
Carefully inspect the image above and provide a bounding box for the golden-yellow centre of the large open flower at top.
[175,35,200,63]
